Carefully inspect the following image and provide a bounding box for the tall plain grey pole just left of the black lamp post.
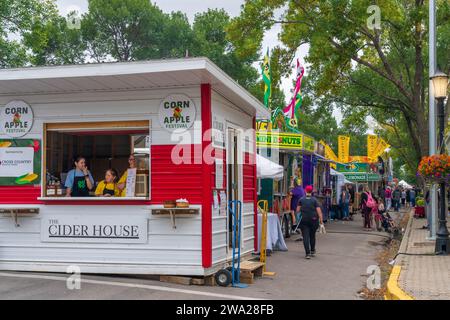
[427,0,436,240]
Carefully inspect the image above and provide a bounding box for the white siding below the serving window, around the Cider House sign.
[0,205,204,275]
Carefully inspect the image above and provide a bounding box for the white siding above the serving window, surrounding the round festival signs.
[0,87,201,145]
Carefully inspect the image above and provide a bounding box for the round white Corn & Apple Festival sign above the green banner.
[0,101,33,138]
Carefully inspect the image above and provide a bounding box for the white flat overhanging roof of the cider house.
[0,58,270,119]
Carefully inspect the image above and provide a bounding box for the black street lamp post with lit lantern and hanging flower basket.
[431,71,450,254]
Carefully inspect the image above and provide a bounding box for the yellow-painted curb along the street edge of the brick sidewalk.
[384,212,414,300]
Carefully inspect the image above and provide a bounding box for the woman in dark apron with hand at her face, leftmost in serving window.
[65,157,94,197]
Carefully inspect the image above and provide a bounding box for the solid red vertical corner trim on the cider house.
[200,84,213,268]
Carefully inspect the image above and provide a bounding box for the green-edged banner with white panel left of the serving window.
[0,139,41,186]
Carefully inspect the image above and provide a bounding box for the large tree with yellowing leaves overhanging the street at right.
[229,0,450,170]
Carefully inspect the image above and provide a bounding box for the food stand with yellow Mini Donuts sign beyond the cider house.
[256,121,331,234]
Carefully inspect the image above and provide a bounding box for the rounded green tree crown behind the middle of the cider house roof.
[81,0,165,61]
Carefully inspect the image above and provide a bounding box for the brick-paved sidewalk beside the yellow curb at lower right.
[396,212,450,300]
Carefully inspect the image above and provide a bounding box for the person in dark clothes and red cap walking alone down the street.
[298,186,323,259]
